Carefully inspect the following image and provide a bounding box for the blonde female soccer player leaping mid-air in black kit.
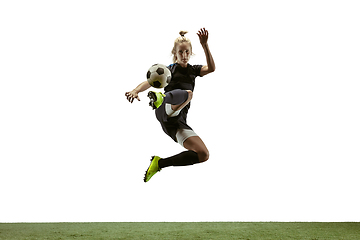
[125,28,215,182]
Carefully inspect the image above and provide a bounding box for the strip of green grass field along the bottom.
[0,222,360,240]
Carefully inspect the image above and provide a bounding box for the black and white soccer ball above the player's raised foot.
[146,64,171,88]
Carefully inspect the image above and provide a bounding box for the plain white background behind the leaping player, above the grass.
[0,0,360,222]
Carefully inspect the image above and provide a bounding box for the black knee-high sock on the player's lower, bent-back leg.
[159,150,200,169]
